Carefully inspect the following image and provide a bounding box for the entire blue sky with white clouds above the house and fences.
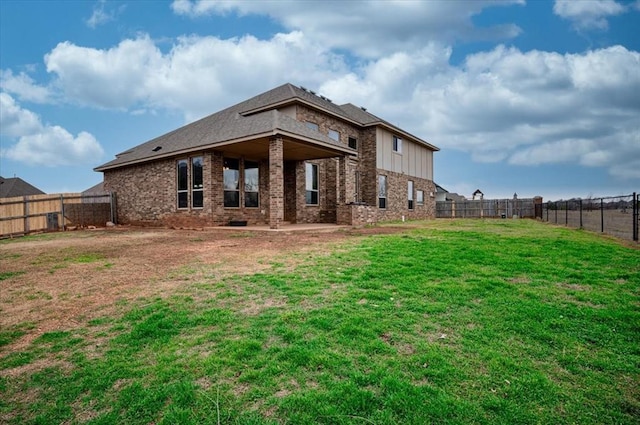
[0,0,640,200]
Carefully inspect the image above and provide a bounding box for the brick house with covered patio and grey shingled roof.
[95,84,439,229]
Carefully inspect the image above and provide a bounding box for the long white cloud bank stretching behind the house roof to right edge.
[45,27,640,178]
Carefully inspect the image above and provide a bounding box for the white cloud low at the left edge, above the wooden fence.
[0,93,104,167]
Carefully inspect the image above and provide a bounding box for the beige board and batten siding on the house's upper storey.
[376,128,433,180]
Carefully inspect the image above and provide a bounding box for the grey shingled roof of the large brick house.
[95,84,438,171]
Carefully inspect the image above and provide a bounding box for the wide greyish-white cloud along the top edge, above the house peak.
[171,0,524,58]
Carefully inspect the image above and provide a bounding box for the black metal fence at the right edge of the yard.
[542,192,640,242]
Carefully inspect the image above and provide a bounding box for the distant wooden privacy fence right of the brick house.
[436,198,542,218]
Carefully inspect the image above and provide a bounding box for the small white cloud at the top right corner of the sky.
[553,0,626,30]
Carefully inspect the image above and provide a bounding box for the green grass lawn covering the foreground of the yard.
[0,220,640,424]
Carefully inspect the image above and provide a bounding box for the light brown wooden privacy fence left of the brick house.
[0,192,116,238]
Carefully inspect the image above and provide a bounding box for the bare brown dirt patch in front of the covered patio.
[0,226,406,354]
